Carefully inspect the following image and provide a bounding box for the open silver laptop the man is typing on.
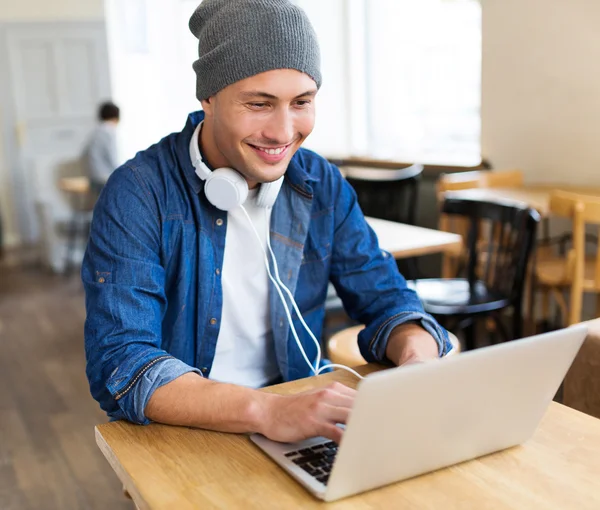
[251,325,587,501]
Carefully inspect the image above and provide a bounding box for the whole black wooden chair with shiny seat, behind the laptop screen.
[410,193,540,349]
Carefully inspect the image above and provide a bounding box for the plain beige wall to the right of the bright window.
[482,0,600,185]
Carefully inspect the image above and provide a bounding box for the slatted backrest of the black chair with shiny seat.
[442,193,540,313]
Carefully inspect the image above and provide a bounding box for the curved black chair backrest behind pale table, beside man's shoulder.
[344,165,423,225]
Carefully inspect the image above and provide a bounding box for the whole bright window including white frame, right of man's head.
[297,0,481,166]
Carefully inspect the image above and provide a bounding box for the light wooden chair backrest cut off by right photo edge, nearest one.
[550,190,600,325]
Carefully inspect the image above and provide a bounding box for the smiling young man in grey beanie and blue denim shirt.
[82,0,450,441]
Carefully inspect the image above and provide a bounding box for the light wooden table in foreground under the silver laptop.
[96,364,600,510]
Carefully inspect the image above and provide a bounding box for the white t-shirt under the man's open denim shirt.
[204,188,279,388]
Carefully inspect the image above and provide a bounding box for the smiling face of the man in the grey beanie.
[202,69,317,187]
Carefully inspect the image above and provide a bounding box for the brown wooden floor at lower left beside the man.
[0,265,134,510]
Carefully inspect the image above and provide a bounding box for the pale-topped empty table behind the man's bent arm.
[367,217,463,259]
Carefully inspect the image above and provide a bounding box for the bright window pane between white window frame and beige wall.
[365,0,481,165]
